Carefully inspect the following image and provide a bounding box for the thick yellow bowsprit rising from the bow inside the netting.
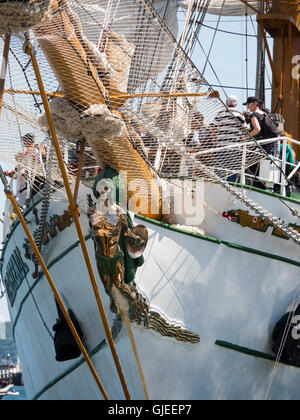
[34,0,161,219]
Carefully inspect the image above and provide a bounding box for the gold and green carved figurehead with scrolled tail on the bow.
[88,187,200,343]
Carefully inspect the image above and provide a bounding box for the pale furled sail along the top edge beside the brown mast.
[180,0,260,16]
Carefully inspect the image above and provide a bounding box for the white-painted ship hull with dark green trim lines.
[2,185,300,400]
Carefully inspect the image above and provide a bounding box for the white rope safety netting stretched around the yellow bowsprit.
[1,0,265,190]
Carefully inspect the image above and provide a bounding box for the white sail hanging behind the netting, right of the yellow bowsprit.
[70,0,178,92]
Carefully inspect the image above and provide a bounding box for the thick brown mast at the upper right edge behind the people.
[257,0,300,156]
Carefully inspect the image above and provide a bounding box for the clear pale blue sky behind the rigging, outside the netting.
[0,12,272,321]
